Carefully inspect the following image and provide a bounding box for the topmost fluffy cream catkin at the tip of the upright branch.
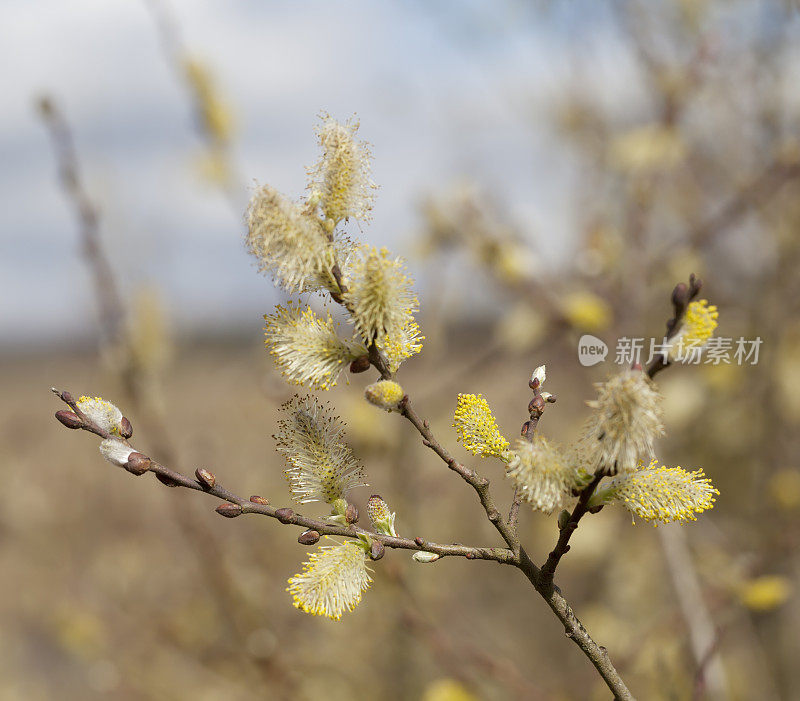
[308,114,377,225]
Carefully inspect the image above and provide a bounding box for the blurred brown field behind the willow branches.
[0,314,800,699]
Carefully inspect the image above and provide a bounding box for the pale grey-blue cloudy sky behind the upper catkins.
[0,0,631,347]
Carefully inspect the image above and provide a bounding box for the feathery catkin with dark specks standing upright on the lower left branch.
[274,396,365,504]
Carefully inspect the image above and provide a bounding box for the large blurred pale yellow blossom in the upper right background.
[610,124,686,173]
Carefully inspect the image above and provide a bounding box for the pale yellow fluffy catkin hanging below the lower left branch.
[286,541,372,621]
